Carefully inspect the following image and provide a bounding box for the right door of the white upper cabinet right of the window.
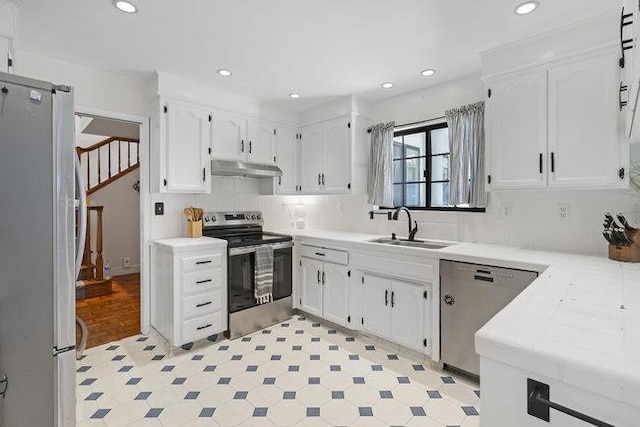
[549,53,623,188]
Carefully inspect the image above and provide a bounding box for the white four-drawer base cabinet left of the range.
[151,237,227,347]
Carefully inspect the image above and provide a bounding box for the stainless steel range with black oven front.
[202,211,293,339]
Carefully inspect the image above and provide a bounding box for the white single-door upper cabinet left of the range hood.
[158,100,211,193]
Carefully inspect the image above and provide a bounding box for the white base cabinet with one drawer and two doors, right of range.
[300,245,349,326]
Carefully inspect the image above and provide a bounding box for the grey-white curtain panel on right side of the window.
[445,101,487,208]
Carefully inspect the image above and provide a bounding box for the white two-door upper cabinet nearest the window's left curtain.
[301,116,354,194]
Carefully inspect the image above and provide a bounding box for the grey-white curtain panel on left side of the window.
[367,122,395,207]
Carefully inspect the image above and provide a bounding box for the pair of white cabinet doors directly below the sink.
[361,272,428,351]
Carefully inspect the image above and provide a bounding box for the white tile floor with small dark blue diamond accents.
[76,316,480,427]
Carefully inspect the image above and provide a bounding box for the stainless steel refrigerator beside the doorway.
[0,73,86,427]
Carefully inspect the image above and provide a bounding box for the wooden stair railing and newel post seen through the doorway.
[76,137,140,299]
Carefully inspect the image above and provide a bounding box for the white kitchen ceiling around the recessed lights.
[12,0,620,110]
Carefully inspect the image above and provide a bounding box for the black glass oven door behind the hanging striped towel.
[227,242,293,313]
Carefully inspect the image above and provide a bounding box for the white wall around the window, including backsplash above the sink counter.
[258,77,640,255]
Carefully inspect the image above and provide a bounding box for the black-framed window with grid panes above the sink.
[393,123,484,211]
